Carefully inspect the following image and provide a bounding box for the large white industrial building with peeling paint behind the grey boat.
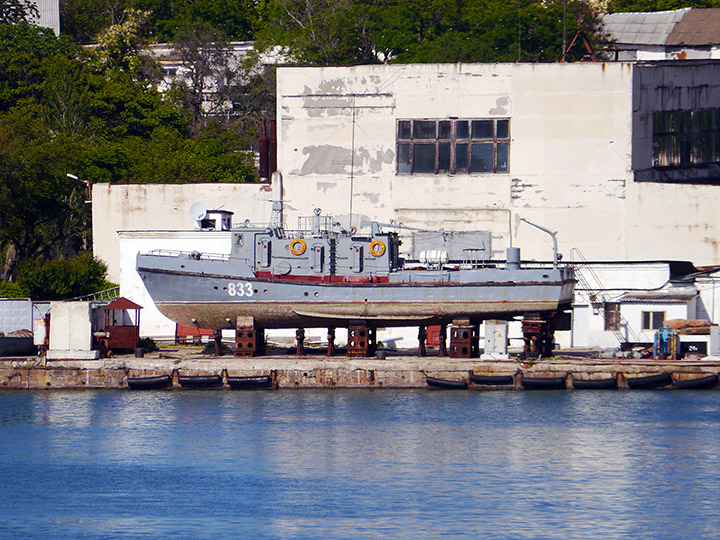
[93,61,720,354]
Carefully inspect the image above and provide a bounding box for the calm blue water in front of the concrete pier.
[0,390,720,539]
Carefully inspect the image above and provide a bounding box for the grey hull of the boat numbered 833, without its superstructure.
[137,254,574,329]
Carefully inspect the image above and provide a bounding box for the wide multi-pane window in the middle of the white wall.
[397,118,510,174]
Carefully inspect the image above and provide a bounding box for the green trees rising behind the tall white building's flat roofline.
[257,0,603,64]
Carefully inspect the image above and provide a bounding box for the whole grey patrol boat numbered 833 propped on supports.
[137,202,575,330]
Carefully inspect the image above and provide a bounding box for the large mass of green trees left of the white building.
[0,20,256,278]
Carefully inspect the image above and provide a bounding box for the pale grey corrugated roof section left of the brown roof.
[602,8,692,45]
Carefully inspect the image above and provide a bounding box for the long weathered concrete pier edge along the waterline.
[0,351,720,389]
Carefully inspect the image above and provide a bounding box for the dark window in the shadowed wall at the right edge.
[653,109,720,168]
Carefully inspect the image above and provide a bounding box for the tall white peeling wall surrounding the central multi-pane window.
[278,63,720,264]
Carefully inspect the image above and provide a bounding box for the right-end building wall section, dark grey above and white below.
[627,62,720,265]
